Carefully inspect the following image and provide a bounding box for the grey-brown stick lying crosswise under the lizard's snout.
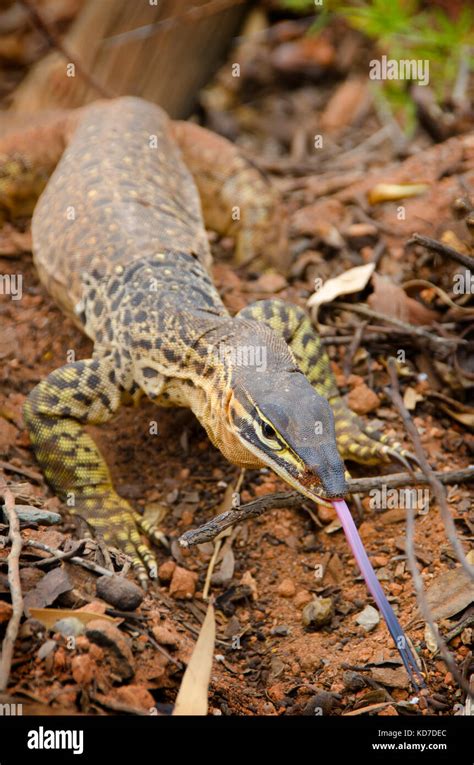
[179,468,474,547]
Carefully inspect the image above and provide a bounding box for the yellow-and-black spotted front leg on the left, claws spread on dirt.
[24,357,158,586]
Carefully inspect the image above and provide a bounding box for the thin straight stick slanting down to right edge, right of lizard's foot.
[385,357,474,581]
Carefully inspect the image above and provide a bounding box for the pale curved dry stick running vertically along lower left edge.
[0,489,23,692]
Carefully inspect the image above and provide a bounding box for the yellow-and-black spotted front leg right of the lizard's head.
[238,299,412,467]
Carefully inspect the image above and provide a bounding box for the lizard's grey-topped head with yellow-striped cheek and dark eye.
[218,322,347,500]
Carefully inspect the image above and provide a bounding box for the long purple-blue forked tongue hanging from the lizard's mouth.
[332,499,425,688]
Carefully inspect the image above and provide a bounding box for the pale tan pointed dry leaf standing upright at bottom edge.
[173,603,216,717]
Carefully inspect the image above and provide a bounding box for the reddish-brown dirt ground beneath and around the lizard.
[0,1,474,715]
